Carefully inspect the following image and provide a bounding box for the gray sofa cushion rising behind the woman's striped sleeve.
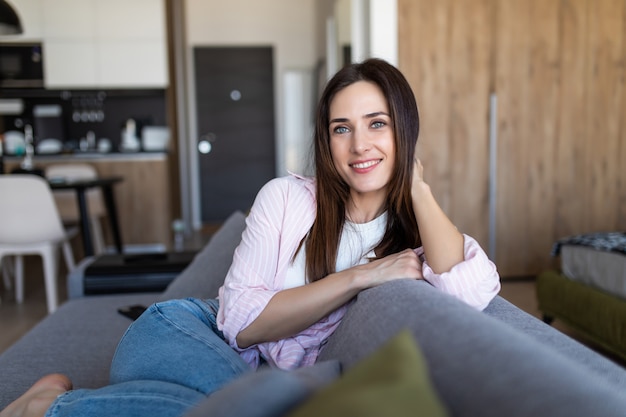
[160,211,246,300]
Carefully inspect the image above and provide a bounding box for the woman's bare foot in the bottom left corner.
[0,374,72,417]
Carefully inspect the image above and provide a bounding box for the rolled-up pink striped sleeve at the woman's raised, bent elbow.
[422,235,500,310]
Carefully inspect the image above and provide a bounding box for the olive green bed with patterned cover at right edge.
[537,232,626,360]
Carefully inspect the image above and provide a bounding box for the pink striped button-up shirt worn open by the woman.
[217,175,500,369]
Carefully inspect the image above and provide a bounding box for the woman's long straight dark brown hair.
[306,58,421,282]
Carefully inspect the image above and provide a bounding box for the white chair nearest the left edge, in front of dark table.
[0,174,77,313]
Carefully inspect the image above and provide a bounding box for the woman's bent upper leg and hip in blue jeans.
[110,299,251,395]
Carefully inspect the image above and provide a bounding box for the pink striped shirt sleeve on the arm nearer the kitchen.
[217,178,315,367]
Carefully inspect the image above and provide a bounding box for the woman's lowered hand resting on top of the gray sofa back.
[351,249,424,289]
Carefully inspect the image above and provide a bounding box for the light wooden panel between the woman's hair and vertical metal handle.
[398,0,493,247]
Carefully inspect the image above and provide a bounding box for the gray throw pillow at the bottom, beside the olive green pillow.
[184,360,341,417]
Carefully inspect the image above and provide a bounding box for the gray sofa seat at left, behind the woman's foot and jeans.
[0,294,158,409]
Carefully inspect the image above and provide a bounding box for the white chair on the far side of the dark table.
[46,163,106,255]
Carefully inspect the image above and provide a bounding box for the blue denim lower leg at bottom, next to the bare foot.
[46,381,206,417]
